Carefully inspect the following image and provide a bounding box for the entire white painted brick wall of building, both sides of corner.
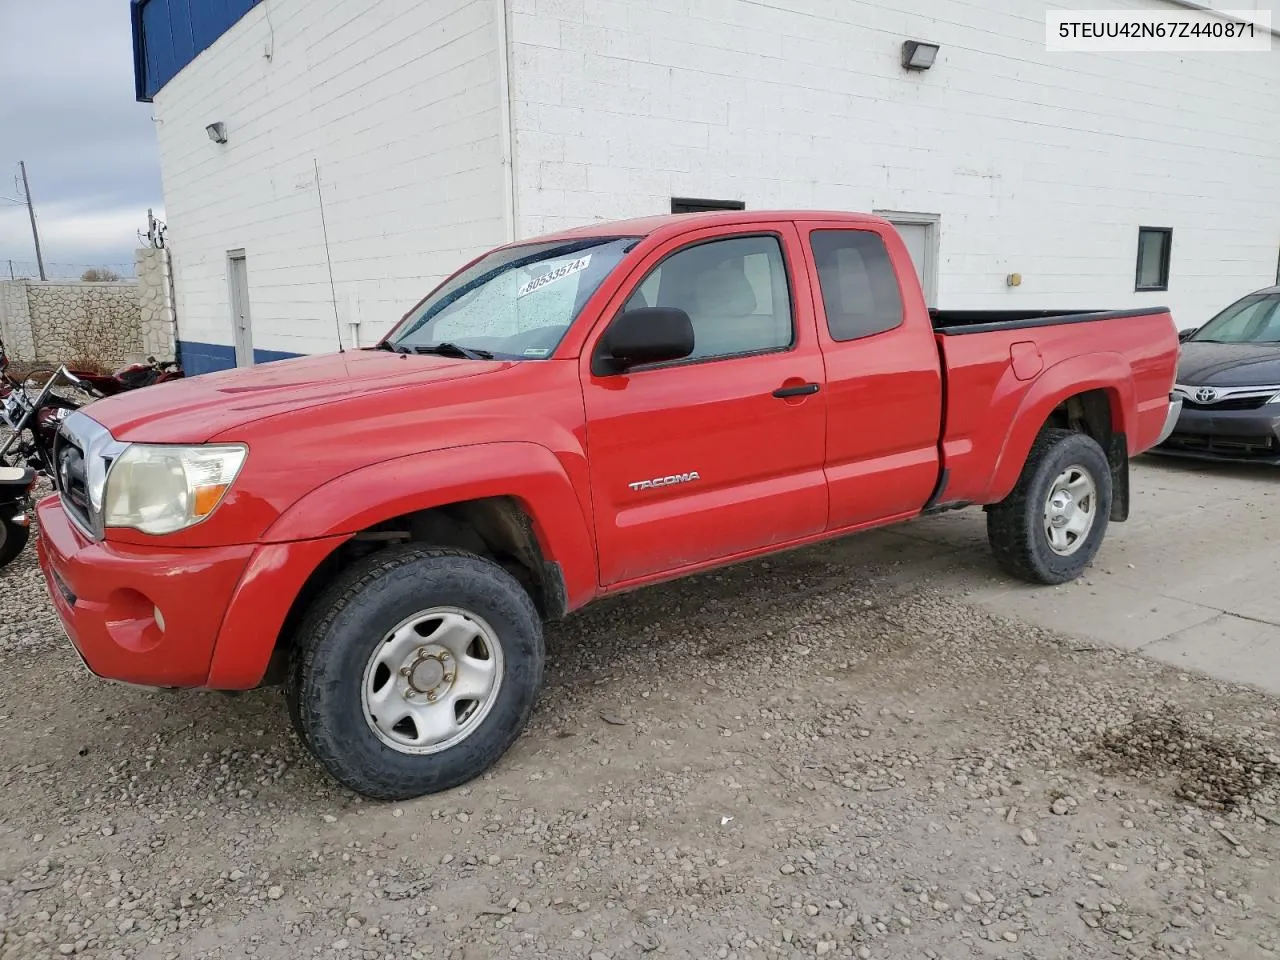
[155,0,1280,363]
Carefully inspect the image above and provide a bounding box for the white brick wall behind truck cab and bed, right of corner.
[509,0,1280,325]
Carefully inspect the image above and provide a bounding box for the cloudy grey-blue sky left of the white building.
[0,0,164,276]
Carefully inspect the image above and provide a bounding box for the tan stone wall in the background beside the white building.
[0,248,174,367]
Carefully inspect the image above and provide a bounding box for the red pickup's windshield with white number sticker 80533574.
[385,237,640,360]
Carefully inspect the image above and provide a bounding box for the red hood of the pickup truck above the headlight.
[86,349,508,443]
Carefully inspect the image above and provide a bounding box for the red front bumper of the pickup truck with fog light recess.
[36,495,347,690]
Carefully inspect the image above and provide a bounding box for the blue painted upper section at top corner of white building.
[129,0,260,102]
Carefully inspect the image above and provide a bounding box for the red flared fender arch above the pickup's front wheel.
[262,442,596,609]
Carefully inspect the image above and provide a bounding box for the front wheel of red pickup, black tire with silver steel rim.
[284,545,545,800]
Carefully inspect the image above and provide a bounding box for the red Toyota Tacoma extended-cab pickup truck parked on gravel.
[38,212,1180,799]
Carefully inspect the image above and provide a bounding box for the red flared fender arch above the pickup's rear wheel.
[983,353,1137,503]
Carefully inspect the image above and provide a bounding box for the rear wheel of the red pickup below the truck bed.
[987,428,1111,585]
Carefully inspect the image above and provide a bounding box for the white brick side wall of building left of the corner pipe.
[155,0,509,368]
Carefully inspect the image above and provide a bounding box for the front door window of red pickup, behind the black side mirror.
[626,236,795,360]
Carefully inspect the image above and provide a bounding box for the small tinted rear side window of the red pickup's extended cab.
[809,230,902,340]
